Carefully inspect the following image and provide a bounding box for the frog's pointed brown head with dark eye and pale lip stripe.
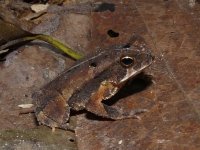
[108,35,154,85]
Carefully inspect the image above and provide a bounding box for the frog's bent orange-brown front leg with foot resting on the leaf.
[86,81,147,120]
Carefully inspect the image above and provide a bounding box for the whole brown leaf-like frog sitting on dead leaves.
[32,34,154,130]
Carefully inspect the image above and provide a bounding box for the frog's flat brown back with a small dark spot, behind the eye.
[32,51,119,110]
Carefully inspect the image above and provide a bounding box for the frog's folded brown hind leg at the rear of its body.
[34,91,72,131]
